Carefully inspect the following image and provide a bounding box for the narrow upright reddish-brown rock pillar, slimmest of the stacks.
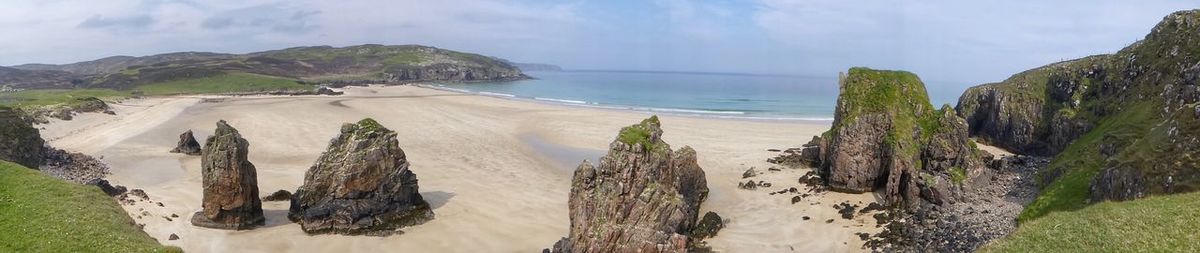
[192,120,266,230]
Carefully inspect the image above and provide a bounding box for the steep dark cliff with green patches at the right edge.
[958,10,1200,201]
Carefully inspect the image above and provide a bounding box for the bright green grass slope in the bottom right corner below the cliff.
[980,193,1200,252]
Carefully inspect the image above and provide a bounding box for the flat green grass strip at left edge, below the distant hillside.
[0,89,131,108]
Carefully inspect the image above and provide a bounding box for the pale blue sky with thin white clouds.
[0,0,1198,85]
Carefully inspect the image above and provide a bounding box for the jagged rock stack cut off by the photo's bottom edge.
[552,116,708,252]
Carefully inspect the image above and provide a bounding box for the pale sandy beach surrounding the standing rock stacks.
[43,86,877,252]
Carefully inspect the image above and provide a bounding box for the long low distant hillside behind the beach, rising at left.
[0,44,528,90]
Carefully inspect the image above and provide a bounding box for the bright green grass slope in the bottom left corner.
[0,161,181,252]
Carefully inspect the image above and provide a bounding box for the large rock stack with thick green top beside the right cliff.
[798,67,990,205]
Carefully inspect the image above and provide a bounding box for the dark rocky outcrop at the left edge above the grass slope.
[0,107,46,168]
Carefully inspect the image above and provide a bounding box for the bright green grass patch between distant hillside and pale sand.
[136,73,313,96]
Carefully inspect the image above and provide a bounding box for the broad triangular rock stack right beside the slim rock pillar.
[288,119,433,235]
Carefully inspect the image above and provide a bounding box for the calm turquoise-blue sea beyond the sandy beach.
[433,71,962,121]
